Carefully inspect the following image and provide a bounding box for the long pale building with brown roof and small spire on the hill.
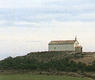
[48,38,82,53]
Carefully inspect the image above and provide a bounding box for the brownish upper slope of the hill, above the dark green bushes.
[23,51,95,65]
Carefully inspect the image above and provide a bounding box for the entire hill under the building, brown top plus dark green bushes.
[0,51,95,72]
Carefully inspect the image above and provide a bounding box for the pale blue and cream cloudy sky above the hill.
[0,0,95,59]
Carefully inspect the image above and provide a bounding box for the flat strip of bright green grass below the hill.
[0,74,91,80]
